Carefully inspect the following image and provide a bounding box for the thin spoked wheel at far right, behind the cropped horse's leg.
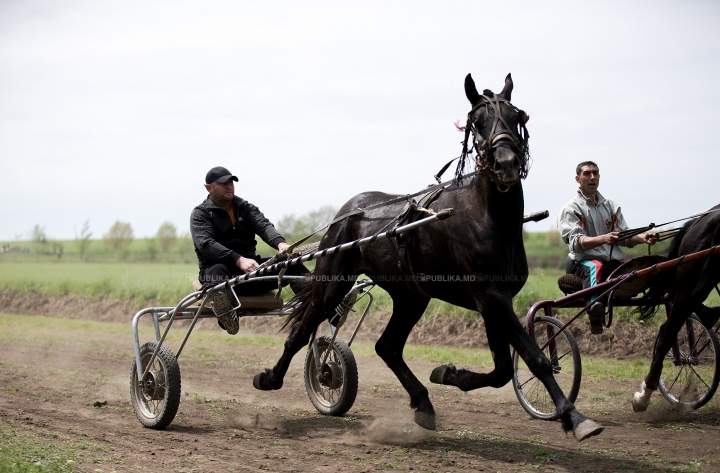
[658,314,720,409]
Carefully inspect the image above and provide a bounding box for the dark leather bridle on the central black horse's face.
[463,95,530,179]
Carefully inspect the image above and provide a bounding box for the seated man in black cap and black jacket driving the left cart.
[190,166,309,335]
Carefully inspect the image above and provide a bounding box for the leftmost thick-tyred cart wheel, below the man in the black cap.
[130,342,180,430]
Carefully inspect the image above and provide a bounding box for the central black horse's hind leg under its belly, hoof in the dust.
[375,294,436,430]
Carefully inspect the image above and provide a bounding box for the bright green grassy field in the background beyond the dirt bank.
[0,231,720,320]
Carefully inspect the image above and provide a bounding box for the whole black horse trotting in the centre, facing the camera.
[253,74,603,441]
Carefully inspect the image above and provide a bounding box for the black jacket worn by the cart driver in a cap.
[190,196,285,273]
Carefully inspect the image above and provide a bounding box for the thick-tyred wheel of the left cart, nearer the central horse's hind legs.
[305,335,358,416]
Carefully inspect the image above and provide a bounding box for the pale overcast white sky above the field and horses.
[0,0,720,241]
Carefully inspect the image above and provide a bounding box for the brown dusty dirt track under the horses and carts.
[0,294,720,472]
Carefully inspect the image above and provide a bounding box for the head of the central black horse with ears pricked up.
[463,74,530,190]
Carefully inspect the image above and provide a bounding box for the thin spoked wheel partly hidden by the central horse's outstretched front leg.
[513,317,582,420]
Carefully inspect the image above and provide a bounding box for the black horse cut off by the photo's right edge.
[633,205,720,412]
